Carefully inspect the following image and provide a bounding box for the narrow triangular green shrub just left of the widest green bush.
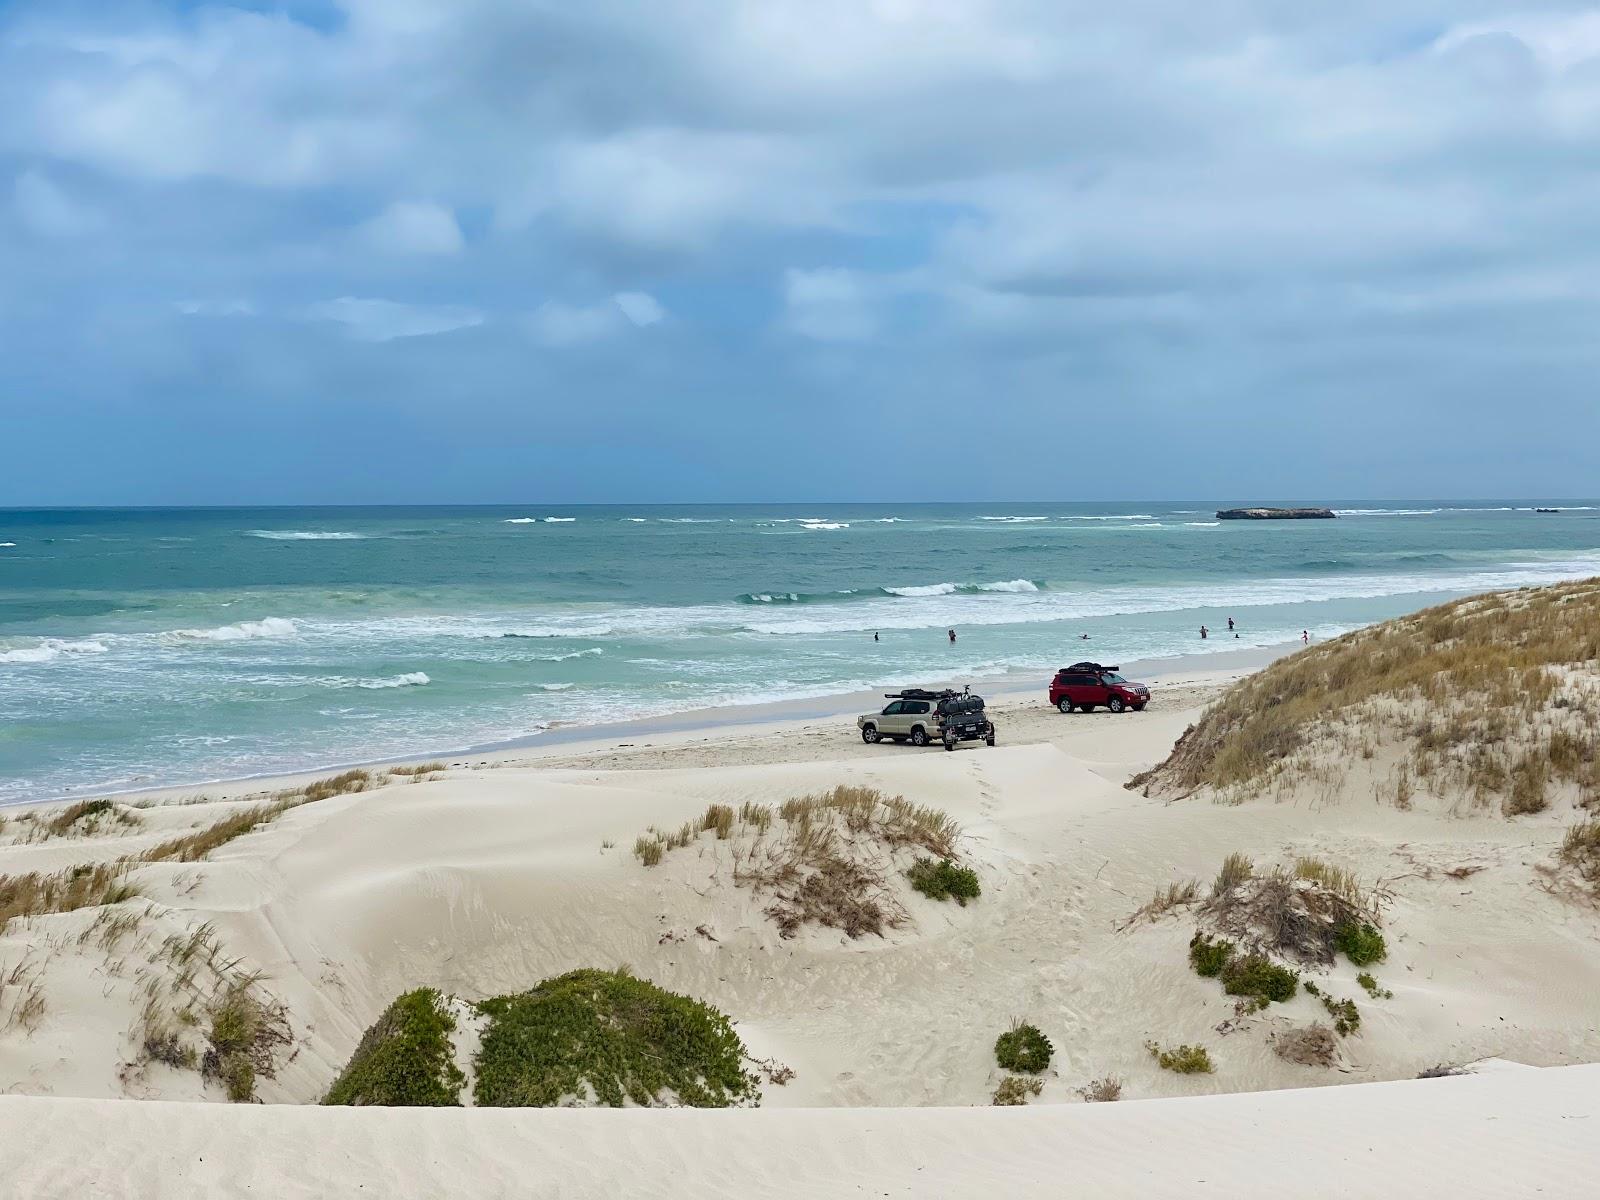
[322,987,466,1107]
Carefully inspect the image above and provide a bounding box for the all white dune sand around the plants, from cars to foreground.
[0,659,1600,1195]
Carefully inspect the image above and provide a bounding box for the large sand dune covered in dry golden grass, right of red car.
[1130,579,1600,814]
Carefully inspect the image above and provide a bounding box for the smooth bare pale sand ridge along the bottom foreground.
[0,1066,1600,1200]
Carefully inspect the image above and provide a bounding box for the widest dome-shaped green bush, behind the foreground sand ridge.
[474,970,758,1107]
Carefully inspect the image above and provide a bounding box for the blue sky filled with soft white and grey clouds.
[0,0,1600,506]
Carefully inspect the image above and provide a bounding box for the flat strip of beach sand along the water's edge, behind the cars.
[18,642,1301,811]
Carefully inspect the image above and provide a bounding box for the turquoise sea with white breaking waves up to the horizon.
[0,501,1600,803]
